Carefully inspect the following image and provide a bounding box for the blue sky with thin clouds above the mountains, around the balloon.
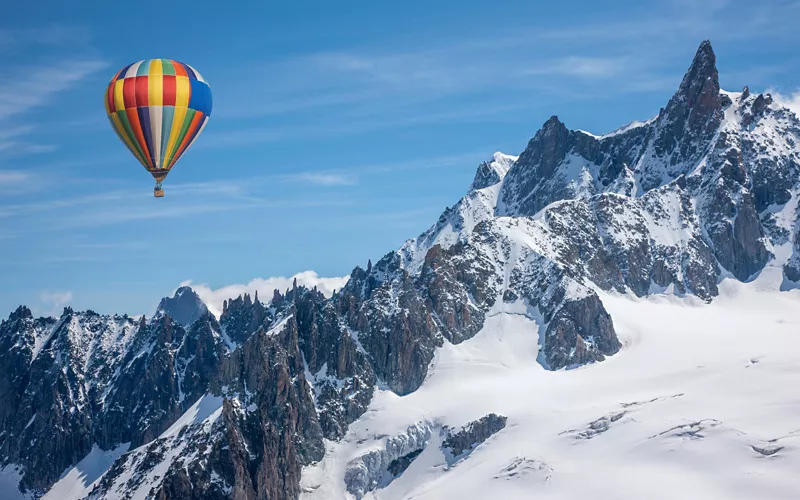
[0,0,800,316]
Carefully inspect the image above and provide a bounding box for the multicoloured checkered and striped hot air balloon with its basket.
[105,59,211,198]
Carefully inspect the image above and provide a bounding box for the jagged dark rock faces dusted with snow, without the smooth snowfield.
[0,42,800,500]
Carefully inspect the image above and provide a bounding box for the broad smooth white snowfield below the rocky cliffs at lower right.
[301,272,800,500]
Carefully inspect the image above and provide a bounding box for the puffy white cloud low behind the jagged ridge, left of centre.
[180,271,350,317]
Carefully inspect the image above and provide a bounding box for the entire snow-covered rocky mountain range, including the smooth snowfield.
[0,42,800,500]
